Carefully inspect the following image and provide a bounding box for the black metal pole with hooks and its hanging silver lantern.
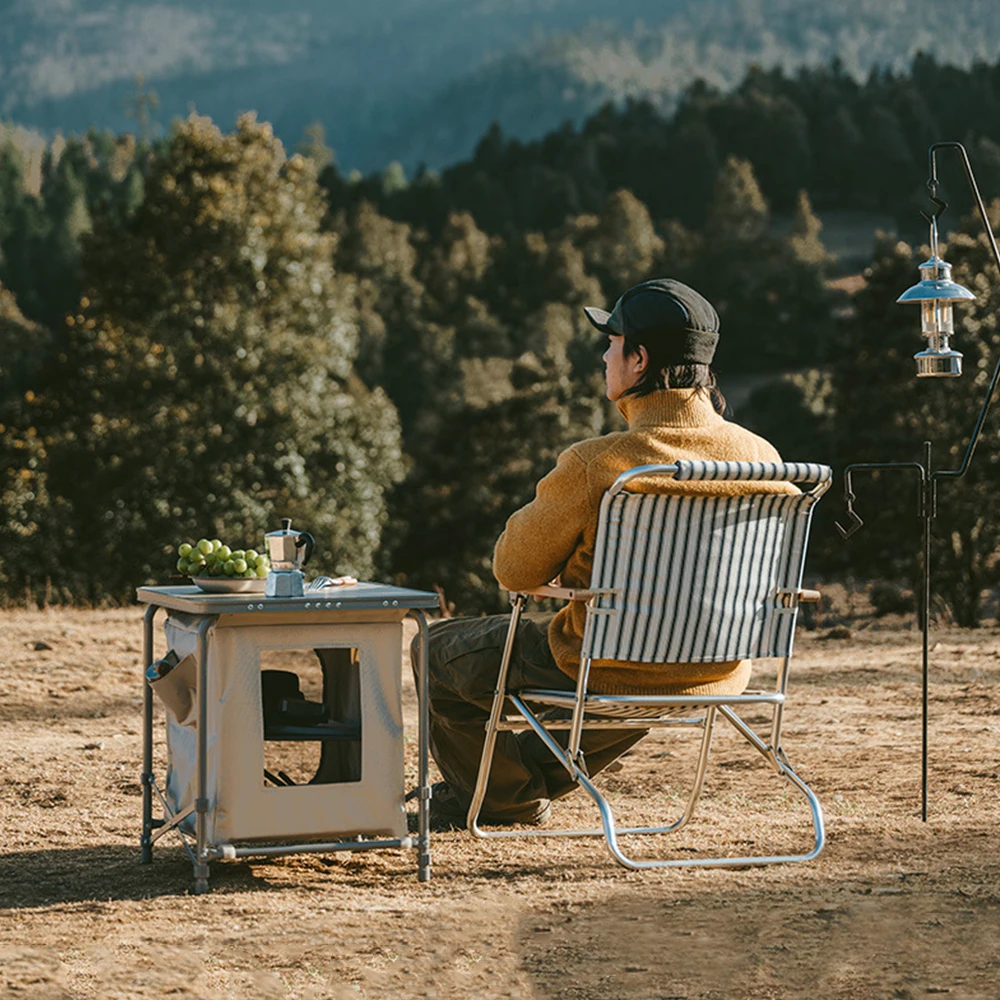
[837,142,1000,822]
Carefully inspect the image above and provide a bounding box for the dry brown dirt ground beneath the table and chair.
[0,609,1000,1000]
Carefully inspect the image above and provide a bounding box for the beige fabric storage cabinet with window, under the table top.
[164,613,406,844]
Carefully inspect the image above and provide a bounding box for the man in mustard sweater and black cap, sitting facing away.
[428,278,795,828]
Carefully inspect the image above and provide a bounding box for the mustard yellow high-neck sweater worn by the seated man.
[493,389,796,694]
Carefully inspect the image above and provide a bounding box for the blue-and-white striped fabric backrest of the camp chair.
[584,462,831,663]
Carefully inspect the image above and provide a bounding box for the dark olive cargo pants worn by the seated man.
[411,614,645,823]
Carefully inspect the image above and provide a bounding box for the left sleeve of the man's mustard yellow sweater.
[493,448,590,590]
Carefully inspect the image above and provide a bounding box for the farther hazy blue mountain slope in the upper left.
[0,0,685,167]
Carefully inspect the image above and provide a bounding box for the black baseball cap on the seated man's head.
[583,278,719,365]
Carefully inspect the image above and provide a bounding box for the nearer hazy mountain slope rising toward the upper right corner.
[382,0,1000,165]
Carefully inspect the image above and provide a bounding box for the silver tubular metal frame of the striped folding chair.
[467,462,832,869]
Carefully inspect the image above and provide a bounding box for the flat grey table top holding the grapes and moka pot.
[136,582,440,615]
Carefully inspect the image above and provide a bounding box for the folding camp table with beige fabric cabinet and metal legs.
[138,583,439,893]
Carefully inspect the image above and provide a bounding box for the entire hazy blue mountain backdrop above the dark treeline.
[0,0,1000,171]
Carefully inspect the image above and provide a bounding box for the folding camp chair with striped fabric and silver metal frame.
[468,462,832,868]
